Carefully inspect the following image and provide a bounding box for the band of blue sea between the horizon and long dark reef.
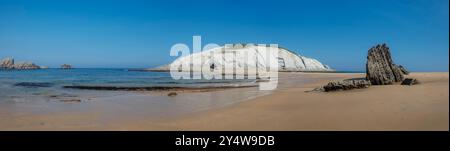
[0,69,253,87]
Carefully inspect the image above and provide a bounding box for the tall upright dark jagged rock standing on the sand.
[366,44,407,85]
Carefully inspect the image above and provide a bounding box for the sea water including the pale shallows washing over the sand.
[0,69,268,120]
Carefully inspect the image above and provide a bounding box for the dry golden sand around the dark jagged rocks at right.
[156,73,449,131]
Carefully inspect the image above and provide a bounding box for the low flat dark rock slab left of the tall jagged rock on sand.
[322,80,371,92]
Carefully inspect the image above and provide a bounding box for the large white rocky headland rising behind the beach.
[151,44,334,73]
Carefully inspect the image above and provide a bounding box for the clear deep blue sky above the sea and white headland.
[0,0,449,71]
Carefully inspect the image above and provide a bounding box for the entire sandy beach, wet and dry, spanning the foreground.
[0,72,449,131]
